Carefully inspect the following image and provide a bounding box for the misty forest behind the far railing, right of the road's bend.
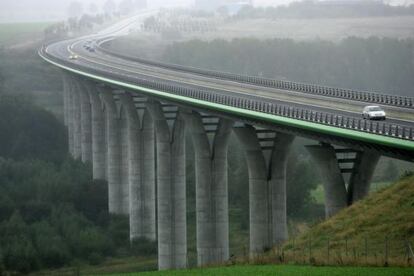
[162,37,414,96]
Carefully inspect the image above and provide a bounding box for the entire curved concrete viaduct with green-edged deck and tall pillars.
[39,14,414,269]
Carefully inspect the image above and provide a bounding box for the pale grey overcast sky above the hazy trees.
[0,0,414,22]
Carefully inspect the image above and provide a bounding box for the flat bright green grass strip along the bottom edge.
[94,265,414,276]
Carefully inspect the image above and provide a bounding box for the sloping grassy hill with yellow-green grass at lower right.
[283,176,414,265]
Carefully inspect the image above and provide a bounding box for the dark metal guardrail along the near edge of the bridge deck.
[41,48,414,141]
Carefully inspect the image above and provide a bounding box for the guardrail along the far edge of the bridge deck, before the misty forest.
[96,38,414,109]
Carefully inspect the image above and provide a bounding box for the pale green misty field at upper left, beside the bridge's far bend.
[0,22,51,46]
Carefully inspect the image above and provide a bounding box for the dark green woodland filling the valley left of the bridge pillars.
[0,95,156,275]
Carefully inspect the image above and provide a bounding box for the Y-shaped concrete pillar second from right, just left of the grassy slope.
[234,126,294,255]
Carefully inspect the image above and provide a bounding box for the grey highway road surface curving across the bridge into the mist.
[40,12,414,160]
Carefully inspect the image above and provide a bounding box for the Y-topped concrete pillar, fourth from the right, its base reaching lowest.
[147,101,187,270]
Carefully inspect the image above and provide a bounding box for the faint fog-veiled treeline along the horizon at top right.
[233,1,414,19]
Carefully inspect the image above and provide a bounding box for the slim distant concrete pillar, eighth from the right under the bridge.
[79,83,92,162]
